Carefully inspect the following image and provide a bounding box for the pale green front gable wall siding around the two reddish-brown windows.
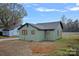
[19,25,44,41]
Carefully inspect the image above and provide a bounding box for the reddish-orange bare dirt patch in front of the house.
[26,42,57,54]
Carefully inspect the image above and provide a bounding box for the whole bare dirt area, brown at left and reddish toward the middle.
[0,40,56,56]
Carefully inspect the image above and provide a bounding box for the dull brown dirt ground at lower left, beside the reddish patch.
[0,40,32,56]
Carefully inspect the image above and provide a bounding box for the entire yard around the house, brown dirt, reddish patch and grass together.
[0,32,79,56]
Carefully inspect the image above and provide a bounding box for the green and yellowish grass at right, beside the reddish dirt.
[48,34,79,56]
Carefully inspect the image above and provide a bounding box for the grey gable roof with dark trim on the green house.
[18,21,63,30]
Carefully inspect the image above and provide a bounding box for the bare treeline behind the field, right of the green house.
[61,15,79,32]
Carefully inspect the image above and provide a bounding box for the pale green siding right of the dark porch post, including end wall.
[44,25,62,40]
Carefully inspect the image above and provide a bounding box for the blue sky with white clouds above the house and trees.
[22,3,79,24]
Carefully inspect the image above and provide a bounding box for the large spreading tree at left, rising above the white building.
[0,3,27,30]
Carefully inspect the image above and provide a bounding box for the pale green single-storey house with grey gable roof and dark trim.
[18,21,63,41]
